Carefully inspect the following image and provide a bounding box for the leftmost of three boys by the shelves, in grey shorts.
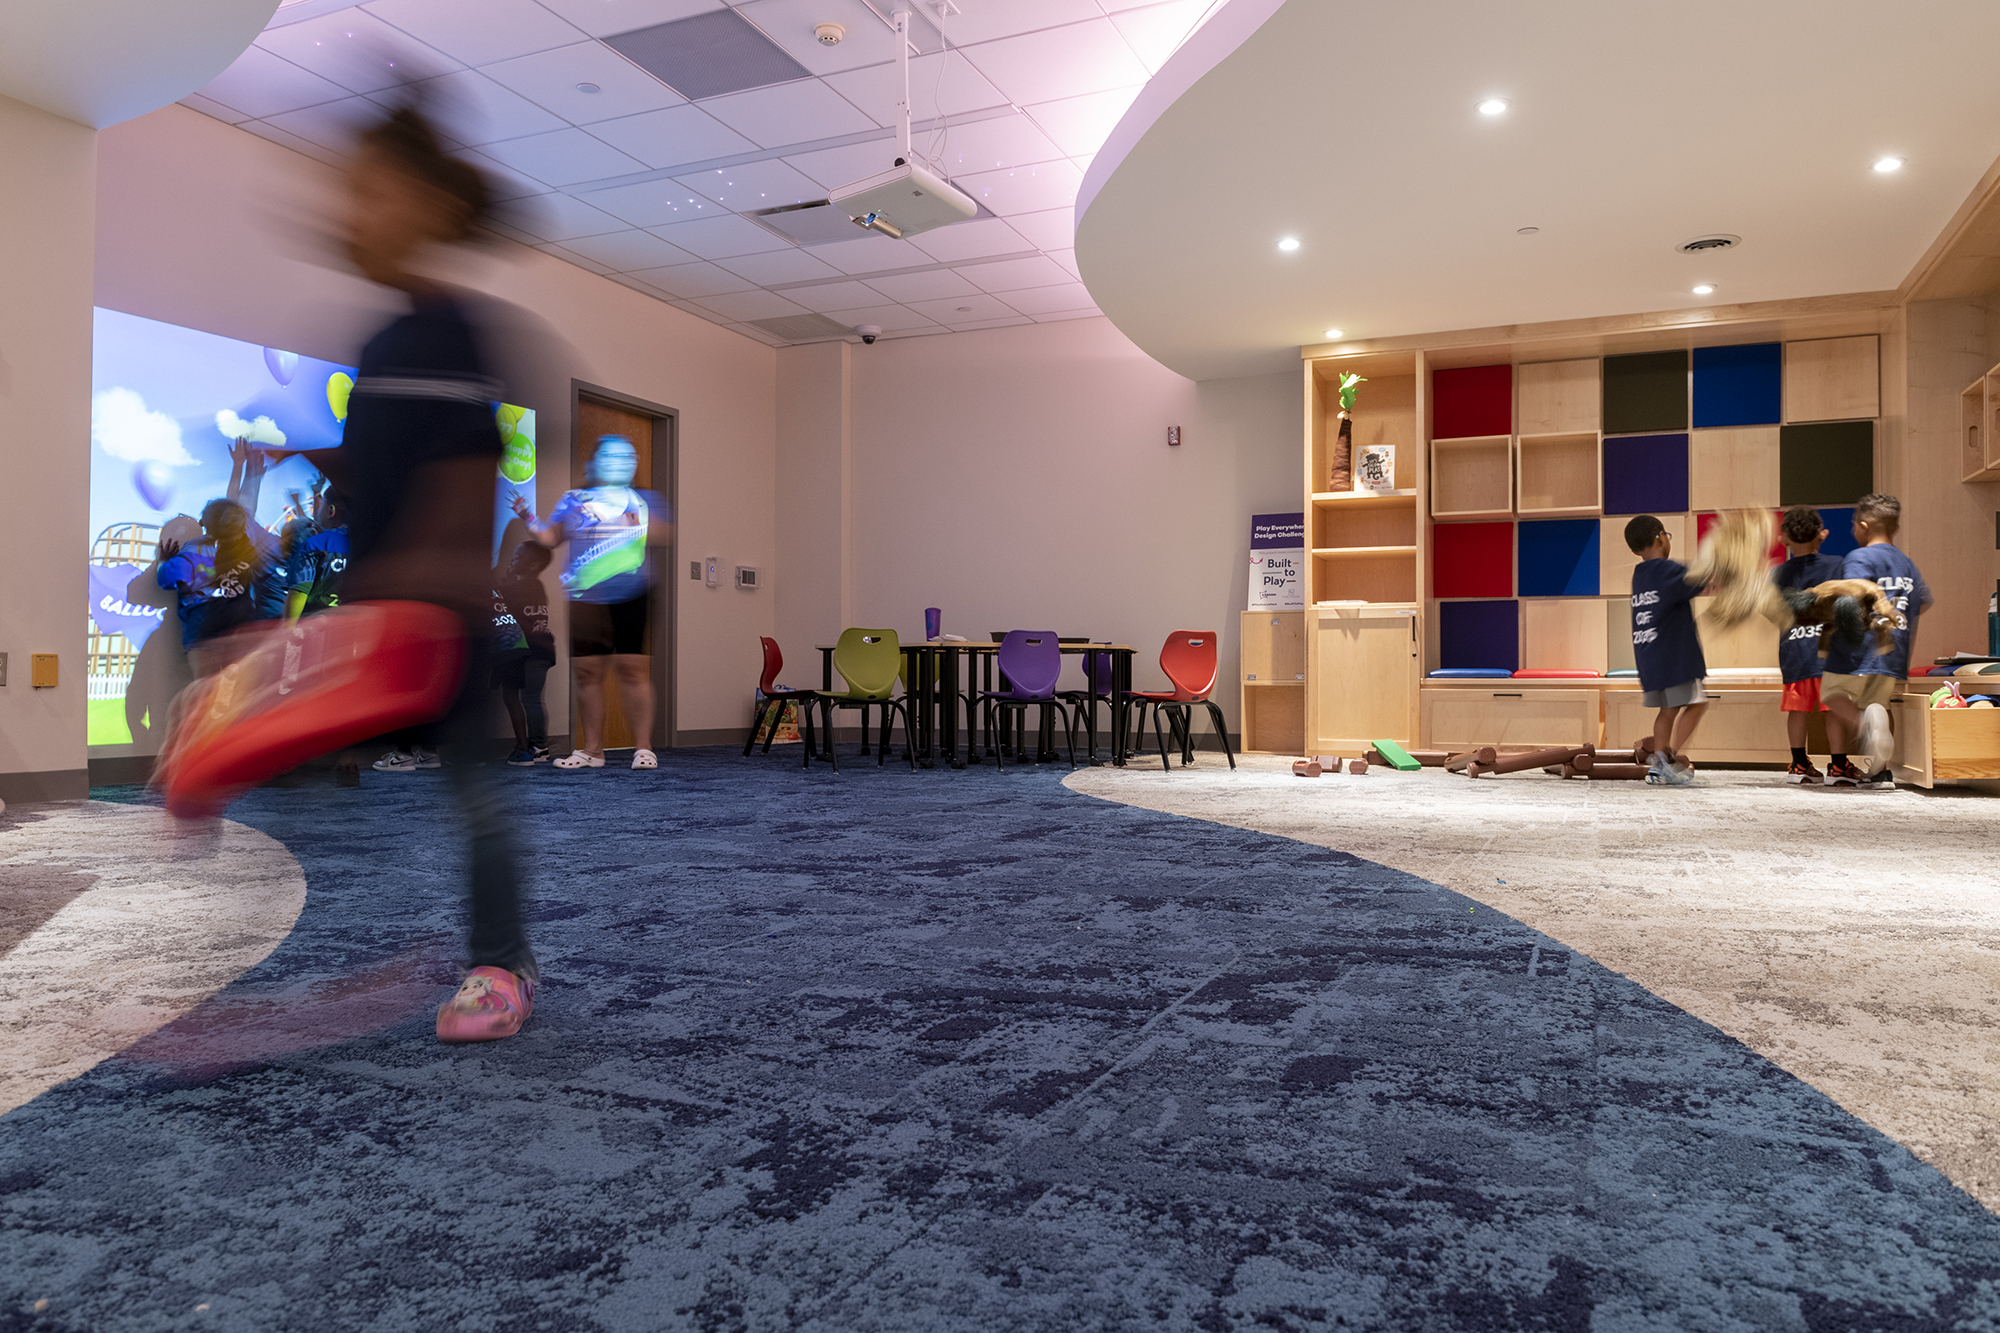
[1626,514,1708,787]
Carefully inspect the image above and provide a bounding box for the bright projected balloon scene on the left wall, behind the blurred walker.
[86,308,536,755]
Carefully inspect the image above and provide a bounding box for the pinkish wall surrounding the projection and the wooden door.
[95,106,778,741]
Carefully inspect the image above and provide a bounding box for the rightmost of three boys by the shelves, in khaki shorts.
[1824,494,1930,787]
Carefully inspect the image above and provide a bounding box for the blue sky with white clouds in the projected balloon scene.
[90,308,354,538]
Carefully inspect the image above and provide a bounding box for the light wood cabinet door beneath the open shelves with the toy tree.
[1306,600,1424,755]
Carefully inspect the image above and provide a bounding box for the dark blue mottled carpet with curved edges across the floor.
[0,751,2000,1333]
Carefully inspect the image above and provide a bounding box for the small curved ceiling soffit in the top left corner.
[0,0,278,130]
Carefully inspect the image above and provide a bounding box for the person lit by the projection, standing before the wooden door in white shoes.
[514,434,672,769]
